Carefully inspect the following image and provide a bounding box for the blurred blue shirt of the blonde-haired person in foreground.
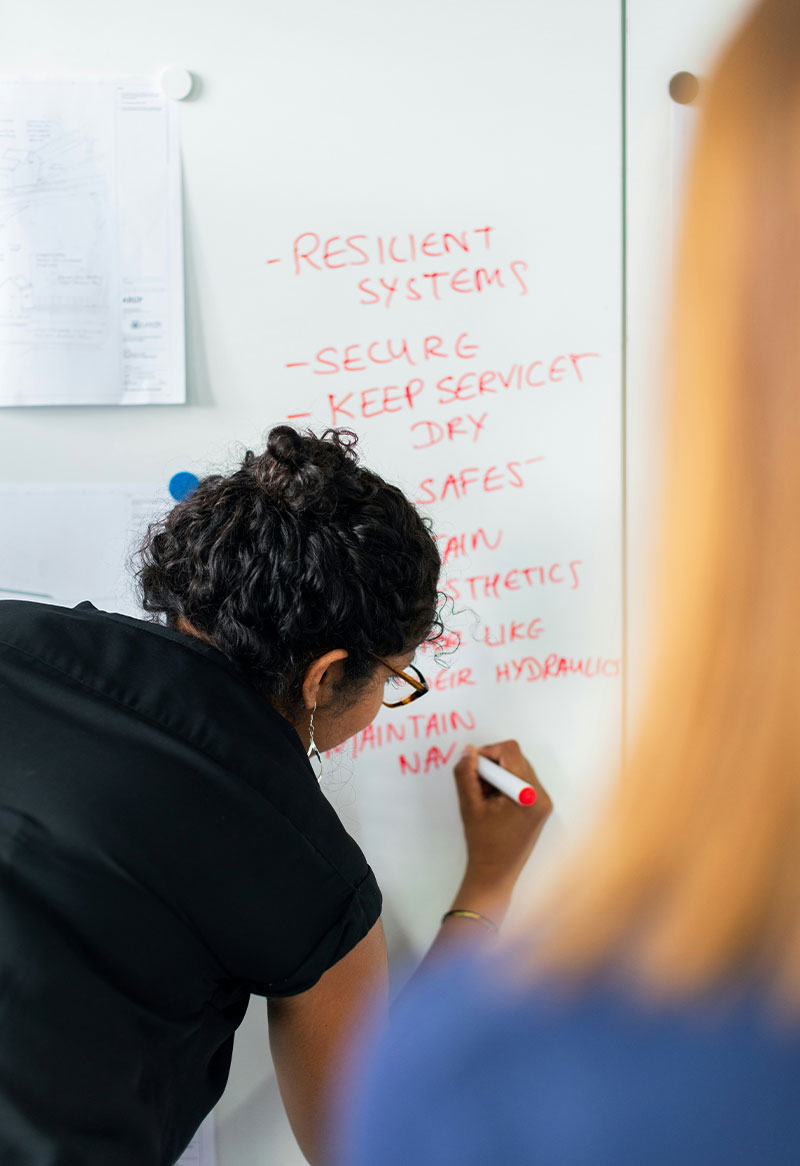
[342,963,800,1166]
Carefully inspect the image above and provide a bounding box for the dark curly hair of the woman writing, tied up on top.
[136,426,442,711]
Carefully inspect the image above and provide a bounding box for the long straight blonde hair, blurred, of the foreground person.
[531,0,800,1004]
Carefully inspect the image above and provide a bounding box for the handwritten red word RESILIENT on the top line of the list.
[292,226,494,275]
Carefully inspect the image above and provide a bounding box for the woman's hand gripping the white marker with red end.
[452,740,553,923]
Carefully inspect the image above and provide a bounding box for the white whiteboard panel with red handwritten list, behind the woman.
[0,0,623,1166]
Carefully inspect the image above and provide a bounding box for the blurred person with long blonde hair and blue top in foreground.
[343,0,800,1166]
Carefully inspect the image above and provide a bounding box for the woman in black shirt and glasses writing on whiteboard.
[0,427,548,1166]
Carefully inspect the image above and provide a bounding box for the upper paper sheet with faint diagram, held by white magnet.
[0,77,185,406]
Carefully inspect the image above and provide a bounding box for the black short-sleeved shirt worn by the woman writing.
[0,600,380,1166]
